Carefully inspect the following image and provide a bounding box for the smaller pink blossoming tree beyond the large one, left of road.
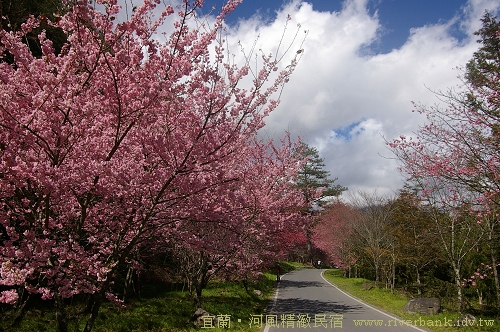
[168,136,310,307]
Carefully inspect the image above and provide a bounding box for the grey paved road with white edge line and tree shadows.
[255,269,426,332]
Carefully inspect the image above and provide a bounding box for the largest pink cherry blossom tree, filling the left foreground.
[0,0,302,331]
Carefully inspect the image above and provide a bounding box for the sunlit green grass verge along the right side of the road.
[325,270,500,332]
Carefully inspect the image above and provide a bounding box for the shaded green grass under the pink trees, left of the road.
[0,263,300,332]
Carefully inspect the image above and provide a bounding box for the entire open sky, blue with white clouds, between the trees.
[126,0,500,200]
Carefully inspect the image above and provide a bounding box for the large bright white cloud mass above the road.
[226,0,499,194]
